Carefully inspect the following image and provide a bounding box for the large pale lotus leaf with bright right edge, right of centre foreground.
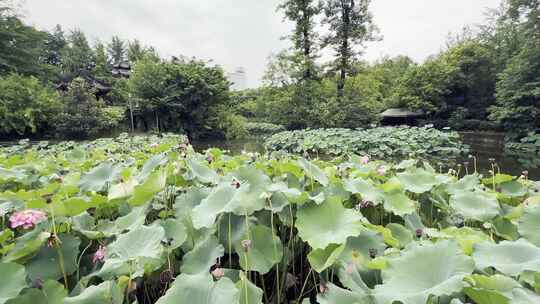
[296,201,365,249]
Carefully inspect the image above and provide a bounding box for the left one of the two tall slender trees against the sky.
[278,0,321,80]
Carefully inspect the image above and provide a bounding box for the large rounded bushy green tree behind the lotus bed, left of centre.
[129,58,233,138]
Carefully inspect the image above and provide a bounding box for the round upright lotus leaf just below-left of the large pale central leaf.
[234,225,283,274]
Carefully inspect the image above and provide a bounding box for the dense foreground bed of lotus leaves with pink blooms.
[0,135,540,304]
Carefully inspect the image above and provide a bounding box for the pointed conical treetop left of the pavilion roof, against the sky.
[62,30,95,78]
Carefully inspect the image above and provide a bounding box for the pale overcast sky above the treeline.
[23,0,501,87]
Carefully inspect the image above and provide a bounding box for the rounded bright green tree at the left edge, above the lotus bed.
[0,74,60,135]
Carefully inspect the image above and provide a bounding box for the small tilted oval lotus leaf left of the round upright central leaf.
[180,235,225,274]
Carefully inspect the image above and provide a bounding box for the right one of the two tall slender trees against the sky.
[323,0,378,97]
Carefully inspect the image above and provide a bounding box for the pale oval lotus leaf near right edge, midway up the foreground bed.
[450,191,500,221]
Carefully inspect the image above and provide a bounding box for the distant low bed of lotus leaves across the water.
[265,127,468,159]
